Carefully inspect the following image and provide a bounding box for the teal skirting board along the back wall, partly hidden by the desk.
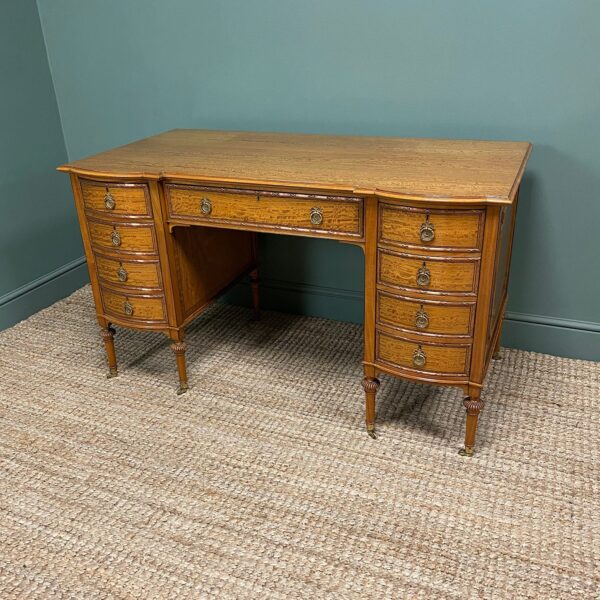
[224,279,600,361]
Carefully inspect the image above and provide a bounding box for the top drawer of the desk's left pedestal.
[81,179,152,218]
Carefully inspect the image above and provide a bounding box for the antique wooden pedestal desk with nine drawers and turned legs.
[60,130,531,455]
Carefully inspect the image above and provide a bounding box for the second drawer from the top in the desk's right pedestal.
[377,250,479,294]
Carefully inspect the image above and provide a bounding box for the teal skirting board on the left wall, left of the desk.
[0,256,90,329]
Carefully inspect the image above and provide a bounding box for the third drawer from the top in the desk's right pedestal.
[377,291,475,336]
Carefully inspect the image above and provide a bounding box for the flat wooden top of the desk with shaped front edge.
[59,129,531,204]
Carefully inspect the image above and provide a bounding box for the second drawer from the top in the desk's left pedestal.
[88,219,156,254]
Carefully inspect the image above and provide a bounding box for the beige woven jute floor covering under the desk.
[0,288,600,600]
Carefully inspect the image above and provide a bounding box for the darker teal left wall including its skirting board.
[0,0,86,328]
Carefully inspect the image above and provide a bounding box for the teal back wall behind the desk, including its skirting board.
[5,0,600,359]
